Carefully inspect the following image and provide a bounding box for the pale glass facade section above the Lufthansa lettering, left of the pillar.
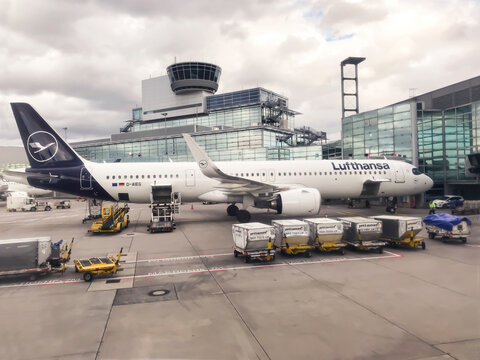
[342,102,414,161]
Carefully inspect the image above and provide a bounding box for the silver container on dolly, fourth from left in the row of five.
[338,216,387,254]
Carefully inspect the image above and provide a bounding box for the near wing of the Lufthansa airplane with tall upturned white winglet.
[183,134,290,195]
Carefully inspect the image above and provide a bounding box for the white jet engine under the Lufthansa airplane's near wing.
[270,188,322,216]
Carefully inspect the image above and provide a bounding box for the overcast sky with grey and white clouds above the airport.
[0,0,480,145]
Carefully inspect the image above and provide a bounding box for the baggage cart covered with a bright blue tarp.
[423,213,472,243]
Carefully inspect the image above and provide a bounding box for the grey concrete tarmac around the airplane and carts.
[0,200,480,360]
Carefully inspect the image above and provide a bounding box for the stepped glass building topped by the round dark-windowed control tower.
[72,62,328,162]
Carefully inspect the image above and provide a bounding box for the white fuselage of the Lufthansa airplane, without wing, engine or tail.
[84,159,433,203]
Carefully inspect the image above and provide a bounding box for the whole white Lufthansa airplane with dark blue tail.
[11,103,433,222]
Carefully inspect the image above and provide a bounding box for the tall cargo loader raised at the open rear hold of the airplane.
[147,184,181,233]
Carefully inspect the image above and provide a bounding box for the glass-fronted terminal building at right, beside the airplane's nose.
[342,76,480,199]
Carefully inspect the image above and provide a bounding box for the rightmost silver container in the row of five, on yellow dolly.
[372,215,426,250]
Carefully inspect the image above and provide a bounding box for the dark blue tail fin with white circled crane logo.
[10,103,83,168]
